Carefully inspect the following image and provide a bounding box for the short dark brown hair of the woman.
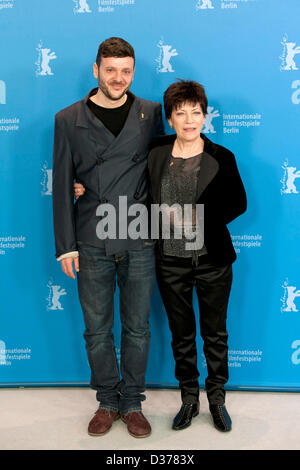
[164,79,207,119]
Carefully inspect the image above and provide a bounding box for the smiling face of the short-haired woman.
[168,103,205,142]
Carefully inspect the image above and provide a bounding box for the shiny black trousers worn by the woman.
[157,255,232,404]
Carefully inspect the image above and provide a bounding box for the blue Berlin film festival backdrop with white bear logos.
[0,0,300,390]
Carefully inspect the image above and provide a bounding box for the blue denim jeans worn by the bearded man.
[78,242,155,414]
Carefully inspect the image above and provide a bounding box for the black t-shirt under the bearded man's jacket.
[87,93,134,137]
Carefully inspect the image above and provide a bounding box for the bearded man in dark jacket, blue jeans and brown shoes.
[53,38,163,437]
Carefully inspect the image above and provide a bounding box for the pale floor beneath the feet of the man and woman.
[0,388,300,450]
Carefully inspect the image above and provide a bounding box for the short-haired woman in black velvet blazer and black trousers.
[148,80,246,431]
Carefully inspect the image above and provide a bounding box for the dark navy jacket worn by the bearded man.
[53,89,163,257]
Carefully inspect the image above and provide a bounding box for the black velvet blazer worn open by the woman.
[148,134,247,266]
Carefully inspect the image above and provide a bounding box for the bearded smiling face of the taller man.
[94,57,134,101]
